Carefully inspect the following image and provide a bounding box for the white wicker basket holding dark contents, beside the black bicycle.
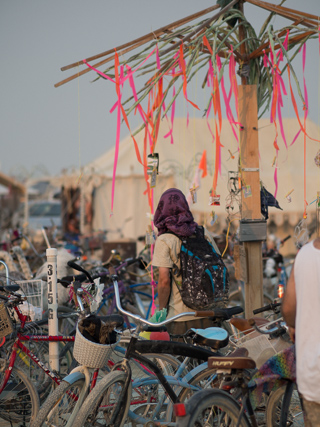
[73,325,118,369]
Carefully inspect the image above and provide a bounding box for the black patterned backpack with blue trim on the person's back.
[174,226,229,310]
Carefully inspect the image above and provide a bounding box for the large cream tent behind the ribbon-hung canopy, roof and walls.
[86,118,320,251]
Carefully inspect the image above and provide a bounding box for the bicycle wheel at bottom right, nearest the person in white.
[266,386,304,427]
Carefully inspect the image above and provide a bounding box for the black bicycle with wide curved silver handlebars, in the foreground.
[63,276,246,427]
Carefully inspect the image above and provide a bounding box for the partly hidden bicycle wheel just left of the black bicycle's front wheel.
[32,377,85,427]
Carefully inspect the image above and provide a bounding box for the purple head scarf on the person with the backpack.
[154,188,197,237]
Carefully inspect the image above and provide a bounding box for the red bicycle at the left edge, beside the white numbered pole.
[0,264,109,422]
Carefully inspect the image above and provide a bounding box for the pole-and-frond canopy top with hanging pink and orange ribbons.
[55,0,319,222]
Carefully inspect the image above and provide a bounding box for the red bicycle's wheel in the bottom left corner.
[0,367,40,425]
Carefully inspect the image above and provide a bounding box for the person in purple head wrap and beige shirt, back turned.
[152,188,220,335]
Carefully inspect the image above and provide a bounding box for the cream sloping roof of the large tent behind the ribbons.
[86,118,320,219]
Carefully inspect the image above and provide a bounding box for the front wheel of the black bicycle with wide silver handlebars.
[72,371,132,427]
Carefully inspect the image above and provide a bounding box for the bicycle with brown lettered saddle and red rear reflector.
[175,321,298,427]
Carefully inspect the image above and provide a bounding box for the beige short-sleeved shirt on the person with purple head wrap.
[152,229,220,322]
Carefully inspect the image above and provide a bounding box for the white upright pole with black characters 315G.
[46,248,59,372]
